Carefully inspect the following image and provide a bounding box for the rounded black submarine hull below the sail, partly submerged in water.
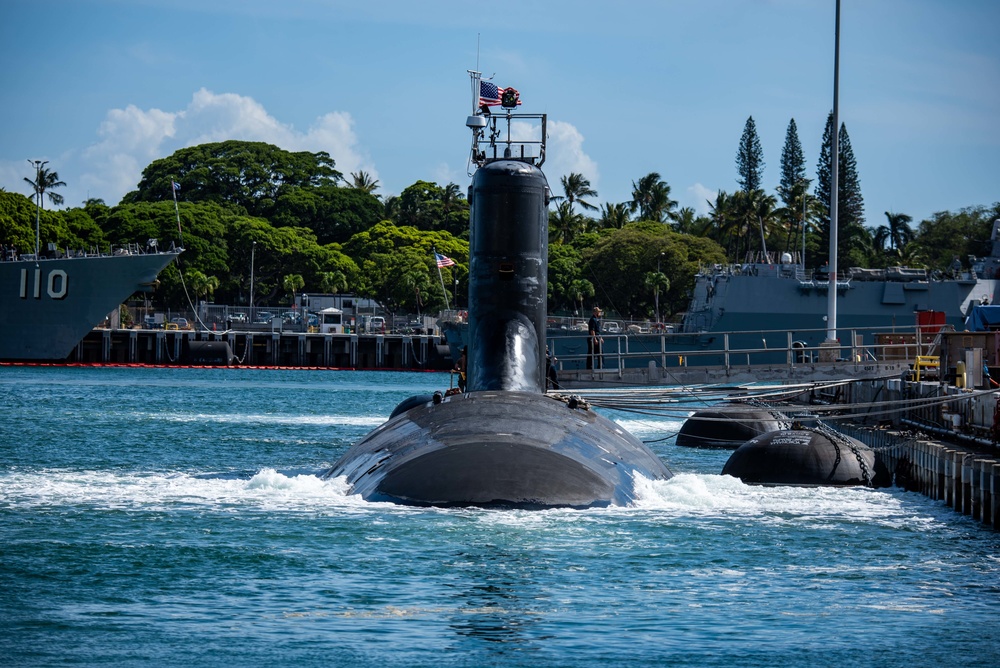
[326,391,671,508]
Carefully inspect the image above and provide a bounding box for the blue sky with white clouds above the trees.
[0,0,1000,226]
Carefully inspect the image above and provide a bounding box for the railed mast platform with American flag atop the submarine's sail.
[465,70,546,176]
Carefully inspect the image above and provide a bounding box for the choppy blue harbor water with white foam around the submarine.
[0,367,1000,668]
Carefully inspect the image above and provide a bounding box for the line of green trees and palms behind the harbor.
[0,133,1000,319]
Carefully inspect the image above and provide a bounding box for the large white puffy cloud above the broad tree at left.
[74,88,378,204]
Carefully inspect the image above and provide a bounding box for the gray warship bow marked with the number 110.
[0,244,182,361]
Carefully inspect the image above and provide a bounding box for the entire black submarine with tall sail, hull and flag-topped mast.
[324,72,672,508]
